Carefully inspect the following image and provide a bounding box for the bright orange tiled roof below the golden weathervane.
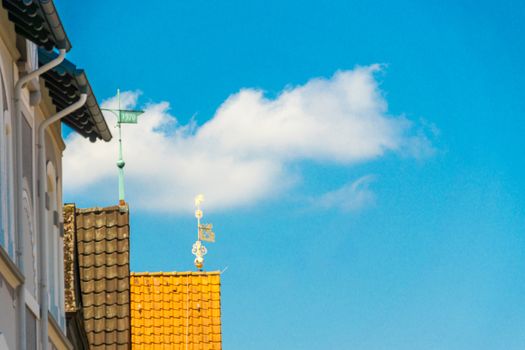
[131,272,222,350]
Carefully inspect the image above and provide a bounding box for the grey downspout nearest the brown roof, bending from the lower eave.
[37,91,87,350]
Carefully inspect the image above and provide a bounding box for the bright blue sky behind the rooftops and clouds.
[57,1,525,350]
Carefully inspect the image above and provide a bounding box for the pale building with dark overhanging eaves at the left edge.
[0,0,111,350]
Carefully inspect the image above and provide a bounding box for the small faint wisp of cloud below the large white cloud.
[314,175,376,211]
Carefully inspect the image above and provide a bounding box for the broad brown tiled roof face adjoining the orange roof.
[76,206,131,350]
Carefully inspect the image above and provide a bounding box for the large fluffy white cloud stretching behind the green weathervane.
[64,65,431,212]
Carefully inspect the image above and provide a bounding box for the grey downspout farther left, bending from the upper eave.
[14,50,66,350]
